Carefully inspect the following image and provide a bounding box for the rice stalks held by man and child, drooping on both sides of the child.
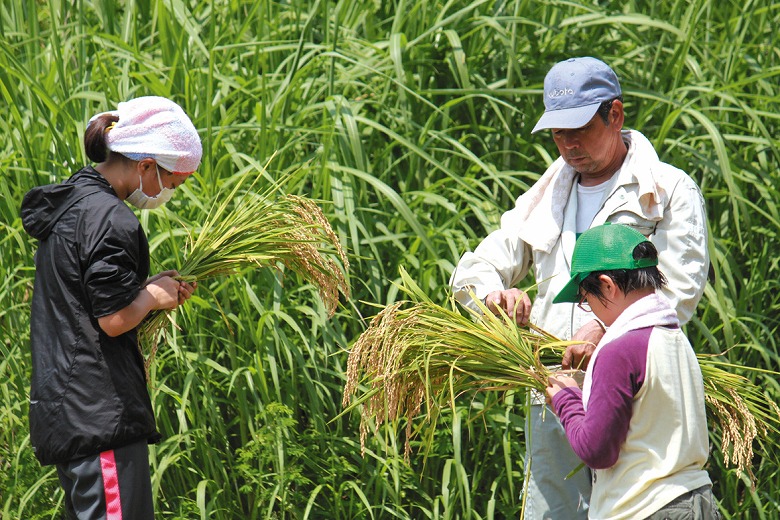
[342,270,780,488]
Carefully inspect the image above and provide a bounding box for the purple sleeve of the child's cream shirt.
[552,327,653,469]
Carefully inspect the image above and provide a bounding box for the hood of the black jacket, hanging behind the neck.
[21,166,114,240]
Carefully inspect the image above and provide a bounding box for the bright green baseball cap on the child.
[553,222,658,303]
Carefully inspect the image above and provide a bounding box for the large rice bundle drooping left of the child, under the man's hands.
[342,269,570,456]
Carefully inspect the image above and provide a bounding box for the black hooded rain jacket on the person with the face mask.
[21,166,160,465]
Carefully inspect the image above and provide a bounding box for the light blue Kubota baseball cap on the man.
[531,56,622,134]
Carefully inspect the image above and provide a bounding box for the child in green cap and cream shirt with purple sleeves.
[547,225,720,519]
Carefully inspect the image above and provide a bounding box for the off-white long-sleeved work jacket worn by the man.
[450,130,709,339]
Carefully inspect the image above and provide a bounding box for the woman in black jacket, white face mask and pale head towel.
[22,97,202,520]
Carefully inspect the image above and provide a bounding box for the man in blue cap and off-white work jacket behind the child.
[450,57,709,520]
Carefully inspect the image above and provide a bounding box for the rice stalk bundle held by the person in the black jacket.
[139,162,350,367]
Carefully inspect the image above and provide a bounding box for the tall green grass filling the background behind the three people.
[0,0,780,519]
